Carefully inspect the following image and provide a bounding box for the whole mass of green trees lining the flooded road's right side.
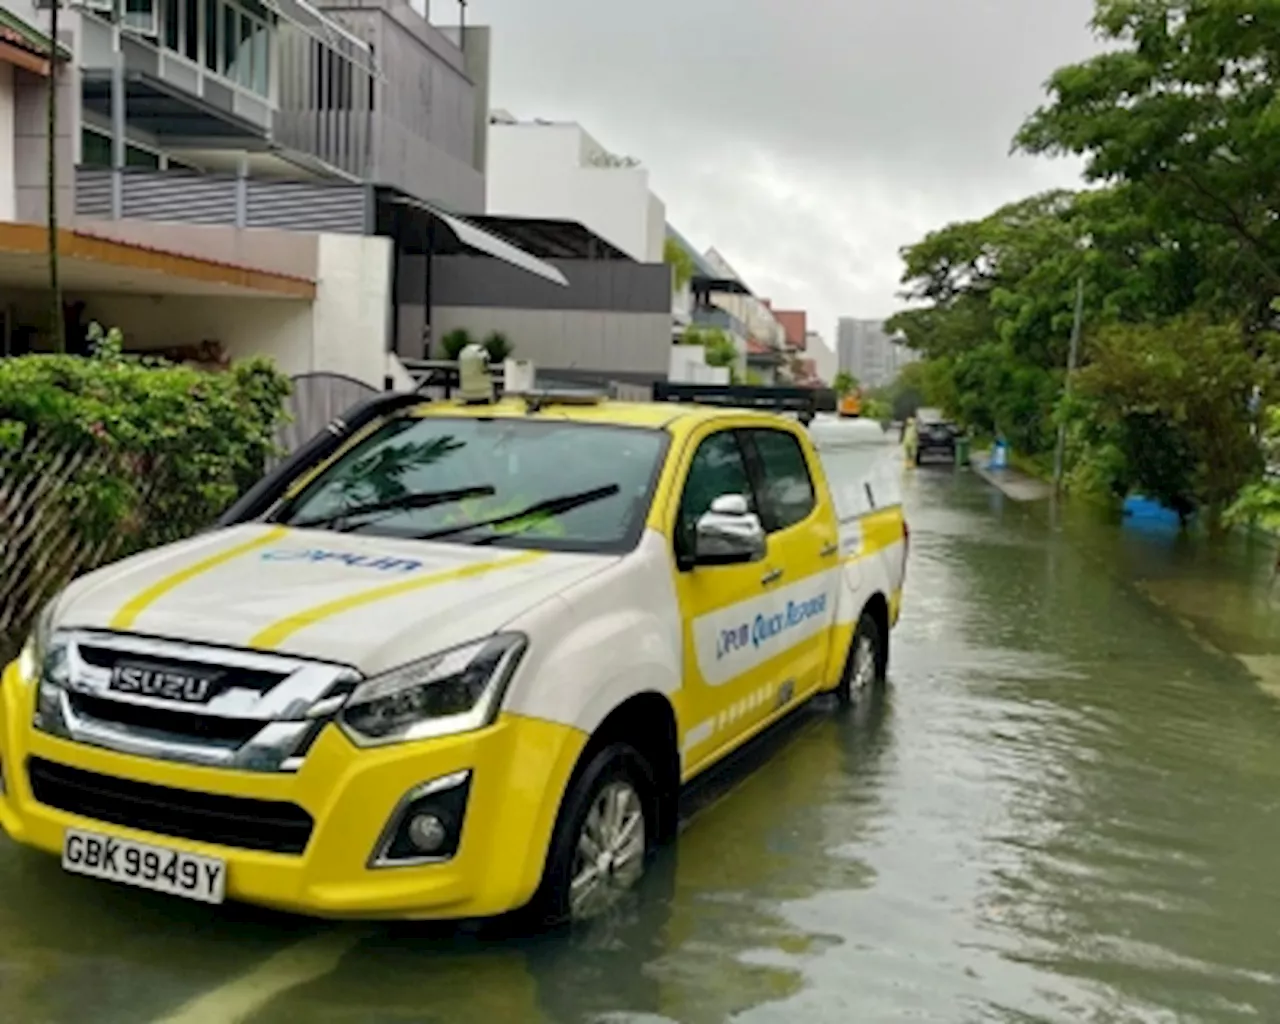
[888,0,1280,520]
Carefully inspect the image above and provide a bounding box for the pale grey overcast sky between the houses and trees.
[468,0,1096,340]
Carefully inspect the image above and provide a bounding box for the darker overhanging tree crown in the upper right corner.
[1016,0,1280,333]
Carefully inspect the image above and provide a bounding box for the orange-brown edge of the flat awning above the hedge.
[0,221,316,300]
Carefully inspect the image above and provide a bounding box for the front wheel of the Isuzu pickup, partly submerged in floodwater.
[529,744,658,925]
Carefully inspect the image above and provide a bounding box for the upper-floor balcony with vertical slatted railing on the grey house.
[73,0,378,179]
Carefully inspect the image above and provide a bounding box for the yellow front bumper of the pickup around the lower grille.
[0,664,586,919]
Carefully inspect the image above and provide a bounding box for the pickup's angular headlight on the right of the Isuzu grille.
[338,634,526,746]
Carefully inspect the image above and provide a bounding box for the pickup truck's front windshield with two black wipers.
[275,416,667,552]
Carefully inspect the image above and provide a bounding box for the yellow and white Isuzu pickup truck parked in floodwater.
[0,381,906,920]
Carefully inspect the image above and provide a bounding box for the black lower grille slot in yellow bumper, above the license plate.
[27,758,315,854]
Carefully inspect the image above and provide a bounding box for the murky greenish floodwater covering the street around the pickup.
[0,470,1280,1024]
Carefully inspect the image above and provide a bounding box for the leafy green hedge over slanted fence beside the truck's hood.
[0,332,289,646]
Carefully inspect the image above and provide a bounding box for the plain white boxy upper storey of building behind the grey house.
[485,110,667,264]
